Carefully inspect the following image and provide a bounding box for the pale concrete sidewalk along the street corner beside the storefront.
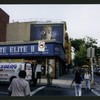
[38,72,100,88]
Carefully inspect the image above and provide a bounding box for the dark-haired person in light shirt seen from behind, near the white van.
[8,70,30,96]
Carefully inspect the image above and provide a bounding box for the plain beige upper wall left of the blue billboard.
[6,22,33,41]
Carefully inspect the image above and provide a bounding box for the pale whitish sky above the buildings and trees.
[0,4,100,46]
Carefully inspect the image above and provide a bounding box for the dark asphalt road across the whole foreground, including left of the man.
[0,85,96,96]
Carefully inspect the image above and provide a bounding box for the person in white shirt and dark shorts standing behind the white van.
[35,60,41,83]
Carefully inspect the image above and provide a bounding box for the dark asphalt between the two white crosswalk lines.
[32,86,96,96]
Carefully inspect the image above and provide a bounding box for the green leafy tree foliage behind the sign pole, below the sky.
[70,36,100,66]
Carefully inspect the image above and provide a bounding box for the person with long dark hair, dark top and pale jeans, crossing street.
[71,71,83,96]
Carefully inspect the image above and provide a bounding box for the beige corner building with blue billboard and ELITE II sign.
[0,21,70,78]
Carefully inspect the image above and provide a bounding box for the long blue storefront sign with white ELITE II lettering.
[0,43,65,59]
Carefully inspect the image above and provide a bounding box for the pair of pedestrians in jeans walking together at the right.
[71,70,91,96]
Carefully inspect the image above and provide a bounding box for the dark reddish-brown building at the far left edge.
[0,8,9,42]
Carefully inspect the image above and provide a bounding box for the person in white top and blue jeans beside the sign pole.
[84,71,91,90]
